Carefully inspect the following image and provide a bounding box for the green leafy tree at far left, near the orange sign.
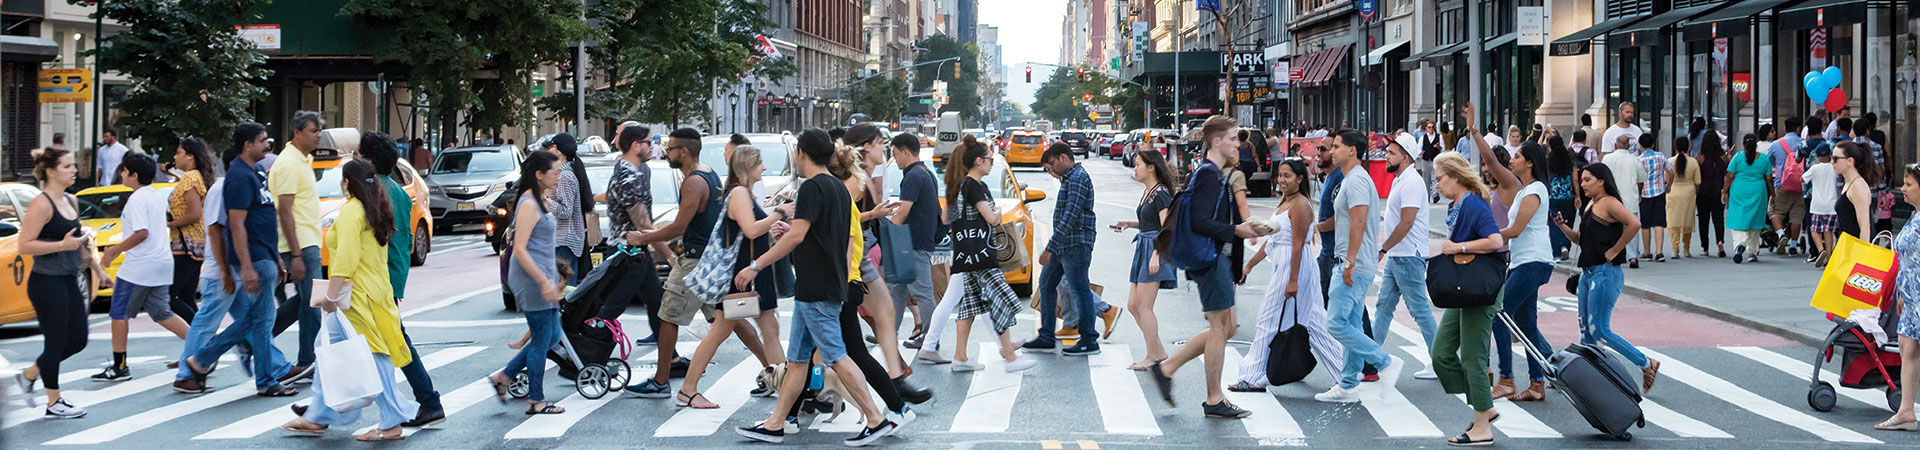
[82,0,271,160]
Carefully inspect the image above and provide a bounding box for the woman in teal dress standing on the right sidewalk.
[1720,135,1774,263]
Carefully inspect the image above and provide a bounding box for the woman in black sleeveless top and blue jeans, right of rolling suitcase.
[1553,160,1658,392]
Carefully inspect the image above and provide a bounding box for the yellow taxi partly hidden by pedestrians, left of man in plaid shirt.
[887,148,1046,296]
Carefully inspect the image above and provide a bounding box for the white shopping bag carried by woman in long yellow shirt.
[313,312,380,412]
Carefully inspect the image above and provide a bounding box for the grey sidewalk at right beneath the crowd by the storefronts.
[1428,204,1834,344]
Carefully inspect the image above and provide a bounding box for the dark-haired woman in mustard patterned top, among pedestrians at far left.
[167,137,219,323]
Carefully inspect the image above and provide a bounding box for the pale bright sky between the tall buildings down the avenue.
[979,0,1066,106]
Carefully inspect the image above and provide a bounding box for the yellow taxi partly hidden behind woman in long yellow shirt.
[313,129,434,271]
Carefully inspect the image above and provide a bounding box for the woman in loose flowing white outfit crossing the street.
[1227,158,1344,392]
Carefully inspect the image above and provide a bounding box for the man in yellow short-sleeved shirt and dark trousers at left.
[267,110,326,385]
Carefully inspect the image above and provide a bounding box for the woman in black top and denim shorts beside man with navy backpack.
[1114,146,1179,371]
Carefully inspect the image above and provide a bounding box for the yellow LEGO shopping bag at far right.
[1811,235,1895,317]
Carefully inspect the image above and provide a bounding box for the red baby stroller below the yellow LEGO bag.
[1807,273,1901,412]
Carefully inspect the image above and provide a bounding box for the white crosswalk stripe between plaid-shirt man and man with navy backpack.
[1087,344,1159,437]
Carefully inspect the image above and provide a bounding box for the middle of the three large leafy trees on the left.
[340,0,588,135]
